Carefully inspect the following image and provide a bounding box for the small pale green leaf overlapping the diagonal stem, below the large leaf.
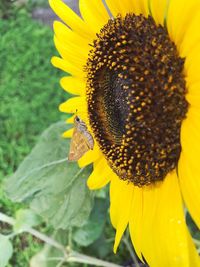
[13,209,42,233]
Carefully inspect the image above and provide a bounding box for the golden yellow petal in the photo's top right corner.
[167,0,200,50]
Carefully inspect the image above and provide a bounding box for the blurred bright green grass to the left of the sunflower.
[0,11,65,182]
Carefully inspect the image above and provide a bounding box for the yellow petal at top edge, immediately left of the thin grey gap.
[79,0,109,33]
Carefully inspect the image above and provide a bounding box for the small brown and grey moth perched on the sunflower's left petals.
[68,116,94,161]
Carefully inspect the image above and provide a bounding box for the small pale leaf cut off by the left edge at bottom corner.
[0,234,13,267]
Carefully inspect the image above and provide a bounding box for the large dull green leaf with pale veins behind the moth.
[5,122,93,229]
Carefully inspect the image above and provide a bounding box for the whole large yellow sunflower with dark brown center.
[50,0,200,267]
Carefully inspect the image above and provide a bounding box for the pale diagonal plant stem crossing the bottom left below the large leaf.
[0,212,122,267]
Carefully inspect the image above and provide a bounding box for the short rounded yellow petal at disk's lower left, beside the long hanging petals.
[87,157,112,190]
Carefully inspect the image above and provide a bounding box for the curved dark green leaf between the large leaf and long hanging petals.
[73,198,108,246]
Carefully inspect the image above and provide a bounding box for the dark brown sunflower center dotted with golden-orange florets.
[86,14,188,186]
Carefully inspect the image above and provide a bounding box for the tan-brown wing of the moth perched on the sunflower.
[68,127,90,161]
